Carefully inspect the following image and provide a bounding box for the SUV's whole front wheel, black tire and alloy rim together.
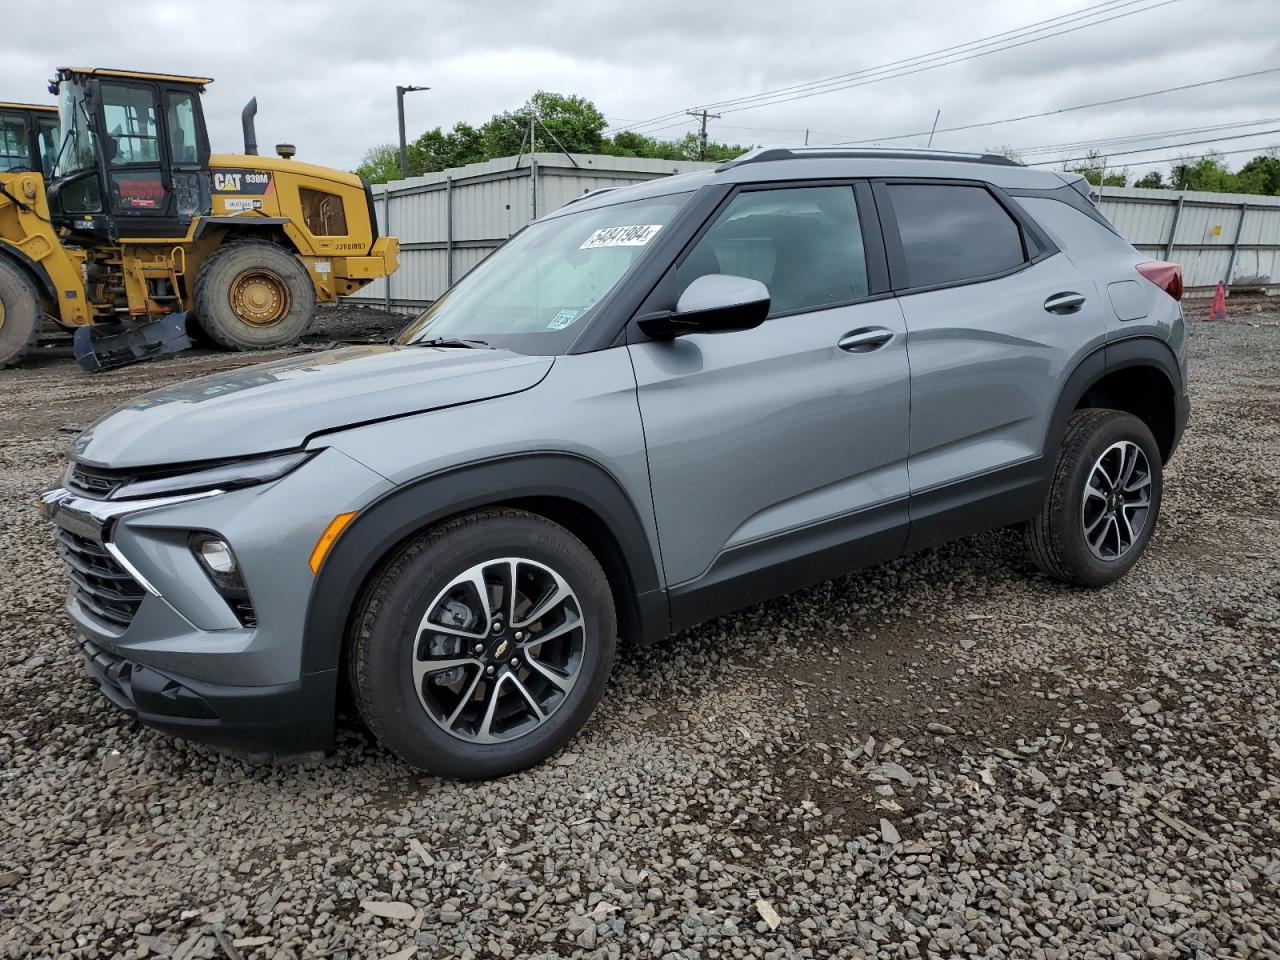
[349,509,617,780]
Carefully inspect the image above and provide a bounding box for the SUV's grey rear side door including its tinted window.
[876,180,1106,549]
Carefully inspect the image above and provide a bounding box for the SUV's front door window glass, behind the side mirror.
[676,187,869,316]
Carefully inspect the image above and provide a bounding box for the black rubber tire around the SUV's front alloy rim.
[348,508,617,780]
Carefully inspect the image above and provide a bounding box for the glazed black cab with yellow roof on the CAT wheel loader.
[49,67,212,242]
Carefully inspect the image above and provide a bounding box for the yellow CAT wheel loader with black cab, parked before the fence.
[0,67,399,370]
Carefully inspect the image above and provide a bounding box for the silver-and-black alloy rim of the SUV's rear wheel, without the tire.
[1080,440,1152,561]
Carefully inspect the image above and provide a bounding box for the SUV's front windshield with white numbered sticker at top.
[397,193,690,356]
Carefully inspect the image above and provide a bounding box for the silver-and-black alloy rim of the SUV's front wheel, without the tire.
[411,557,586,744]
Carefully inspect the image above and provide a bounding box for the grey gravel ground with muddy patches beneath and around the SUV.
[0,303,1280,960]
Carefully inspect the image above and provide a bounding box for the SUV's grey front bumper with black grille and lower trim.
[42,449,389,755]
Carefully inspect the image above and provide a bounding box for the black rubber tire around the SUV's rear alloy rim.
[1024,410,1164,586]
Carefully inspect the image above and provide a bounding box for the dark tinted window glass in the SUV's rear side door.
[888,183,1027,287]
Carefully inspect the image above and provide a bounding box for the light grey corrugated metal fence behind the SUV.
[349,154,1280,310]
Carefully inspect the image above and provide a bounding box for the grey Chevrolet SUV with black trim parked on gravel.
[44,150,1189,777]
